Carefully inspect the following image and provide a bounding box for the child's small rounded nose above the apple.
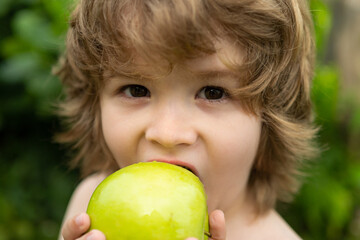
[145,104,198,148]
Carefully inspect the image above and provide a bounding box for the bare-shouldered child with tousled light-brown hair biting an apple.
[57,0,316,240]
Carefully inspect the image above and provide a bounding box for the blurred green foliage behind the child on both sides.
[0,0,360,240]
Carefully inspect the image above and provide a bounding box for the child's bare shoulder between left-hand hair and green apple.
[60,173,108,223]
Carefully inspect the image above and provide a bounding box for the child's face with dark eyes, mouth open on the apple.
[100,42,261,211]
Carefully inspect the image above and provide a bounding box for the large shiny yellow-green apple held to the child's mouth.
[87,162,209,240]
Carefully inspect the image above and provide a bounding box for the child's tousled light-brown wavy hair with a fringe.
[55,0,316,213]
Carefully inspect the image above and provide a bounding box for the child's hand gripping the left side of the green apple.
[61,213,105,240]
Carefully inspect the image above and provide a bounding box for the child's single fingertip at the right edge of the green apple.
[209,210,226,240]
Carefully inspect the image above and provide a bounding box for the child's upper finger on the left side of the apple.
[61,213,90,240]
